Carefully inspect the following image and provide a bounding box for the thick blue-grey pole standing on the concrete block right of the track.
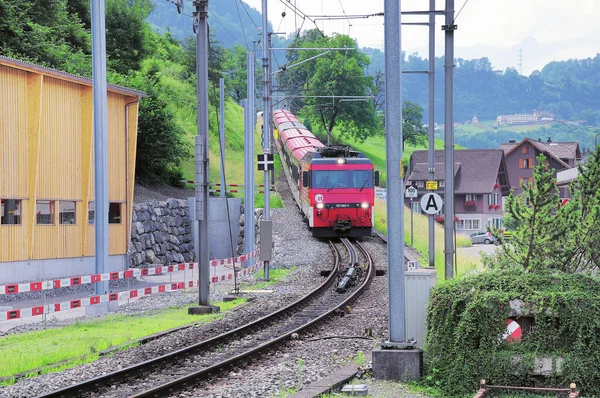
[384,0,406,343]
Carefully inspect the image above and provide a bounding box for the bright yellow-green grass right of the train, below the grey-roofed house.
[375,199,478,278]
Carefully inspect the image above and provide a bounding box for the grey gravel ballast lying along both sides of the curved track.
[0,175,432,397]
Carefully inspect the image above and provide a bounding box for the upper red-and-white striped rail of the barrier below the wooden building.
[0,249,260,295]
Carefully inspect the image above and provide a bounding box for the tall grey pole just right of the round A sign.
[442,0,456,279]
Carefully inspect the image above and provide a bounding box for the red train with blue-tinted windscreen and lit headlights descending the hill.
[273,110,379,238]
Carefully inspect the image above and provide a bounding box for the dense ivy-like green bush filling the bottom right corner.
[425,267,600,397]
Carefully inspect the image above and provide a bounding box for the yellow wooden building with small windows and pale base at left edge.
[0,56,145,283]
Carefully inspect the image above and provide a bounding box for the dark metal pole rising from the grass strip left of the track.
[188,0,219,314]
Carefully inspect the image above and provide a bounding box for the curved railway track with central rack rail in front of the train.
[39,239,375,397]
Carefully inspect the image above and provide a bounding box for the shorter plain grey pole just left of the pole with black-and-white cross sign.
[244,51,255,267]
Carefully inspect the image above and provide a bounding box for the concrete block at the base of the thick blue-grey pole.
[373,349,423,381]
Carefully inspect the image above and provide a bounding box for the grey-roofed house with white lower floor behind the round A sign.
[405,149,510,232]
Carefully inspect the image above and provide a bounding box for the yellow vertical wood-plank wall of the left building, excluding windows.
[0,60,138,262]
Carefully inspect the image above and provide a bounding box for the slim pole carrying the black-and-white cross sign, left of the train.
[262,0,272,280]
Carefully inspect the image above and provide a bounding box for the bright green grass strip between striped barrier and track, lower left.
[0,299,246,384]
